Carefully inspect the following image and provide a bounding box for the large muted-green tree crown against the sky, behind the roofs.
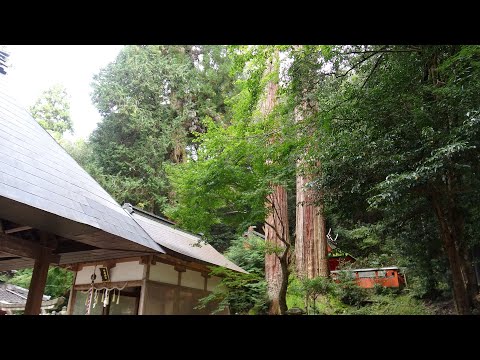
[91,45,233,213]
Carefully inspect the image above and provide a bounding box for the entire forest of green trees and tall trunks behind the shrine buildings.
[4,45,480,314]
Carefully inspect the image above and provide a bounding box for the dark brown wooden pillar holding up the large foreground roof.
[24,247,52,315]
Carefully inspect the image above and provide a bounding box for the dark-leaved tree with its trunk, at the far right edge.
[304,46,480,314]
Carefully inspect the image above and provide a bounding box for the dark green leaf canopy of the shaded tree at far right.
[288,45,480,306]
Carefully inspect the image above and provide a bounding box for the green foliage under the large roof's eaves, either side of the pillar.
[7,266,73,298]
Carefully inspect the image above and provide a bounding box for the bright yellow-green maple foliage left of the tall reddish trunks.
[166,114,267,237]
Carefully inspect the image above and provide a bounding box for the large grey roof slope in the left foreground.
[0,77,163,252]
